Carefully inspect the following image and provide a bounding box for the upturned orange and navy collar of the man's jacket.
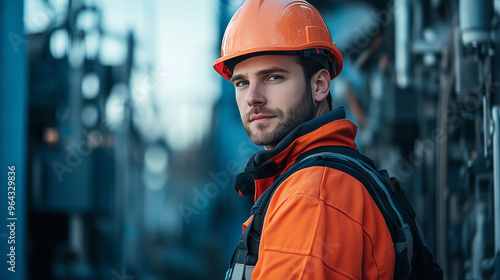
[245,107,357,201]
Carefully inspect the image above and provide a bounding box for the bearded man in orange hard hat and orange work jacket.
[214,0,395,280]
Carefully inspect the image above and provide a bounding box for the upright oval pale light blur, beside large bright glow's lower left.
[105,83,128,129]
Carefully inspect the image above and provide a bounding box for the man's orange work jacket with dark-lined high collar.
[243,109,395,280]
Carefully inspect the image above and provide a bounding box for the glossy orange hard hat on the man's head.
[214,0,343,80]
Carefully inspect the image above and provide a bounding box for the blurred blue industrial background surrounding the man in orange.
[0,0,500,280]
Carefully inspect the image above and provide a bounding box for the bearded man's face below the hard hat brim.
[231,55,315,149]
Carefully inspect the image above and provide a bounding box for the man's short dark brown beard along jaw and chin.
[242,88,316,147]
